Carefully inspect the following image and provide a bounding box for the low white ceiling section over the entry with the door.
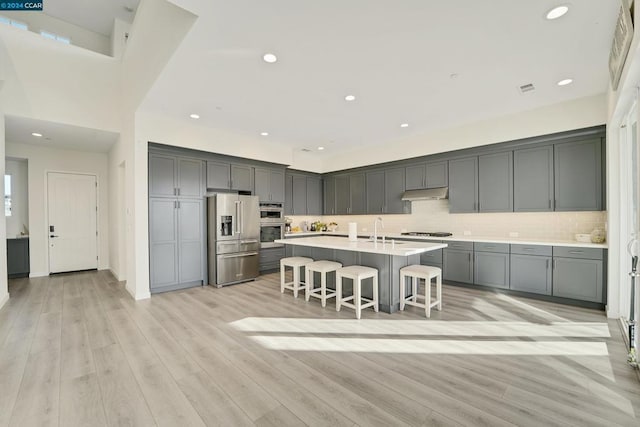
[5,115,118,153]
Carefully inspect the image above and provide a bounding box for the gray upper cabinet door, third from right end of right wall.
[478,151,513,212]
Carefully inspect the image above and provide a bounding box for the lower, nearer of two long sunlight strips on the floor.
[251,336,608,356]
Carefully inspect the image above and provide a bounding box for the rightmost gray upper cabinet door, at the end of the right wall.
[554,138,602,211]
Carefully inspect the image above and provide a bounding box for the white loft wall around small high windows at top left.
[0,12,110,55]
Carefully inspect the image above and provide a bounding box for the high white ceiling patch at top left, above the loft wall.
[42,0,140,36]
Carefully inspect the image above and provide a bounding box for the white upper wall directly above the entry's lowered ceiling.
[0,23,121,132]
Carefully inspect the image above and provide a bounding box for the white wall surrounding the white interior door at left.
[6,141,110,277]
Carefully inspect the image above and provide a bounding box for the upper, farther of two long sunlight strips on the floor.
[230,317,610,338]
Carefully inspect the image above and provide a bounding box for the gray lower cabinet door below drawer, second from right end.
[511,254,552,295]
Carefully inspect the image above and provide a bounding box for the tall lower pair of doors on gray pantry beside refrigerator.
[149,198,205,293]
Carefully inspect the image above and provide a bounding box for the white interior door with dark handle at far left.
[47,172,98,273]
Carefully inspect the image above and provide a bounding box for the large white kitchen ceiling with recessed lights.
[141,0,618,154]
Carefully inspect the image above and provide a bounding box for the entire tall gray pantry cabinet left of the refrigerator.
[149,153,206,293]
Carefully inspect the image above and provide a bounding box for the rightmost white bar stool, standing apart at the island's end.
[400,265,442,317]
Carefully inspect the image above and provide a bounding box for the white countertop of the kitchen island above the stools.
[275,233,447,256]
